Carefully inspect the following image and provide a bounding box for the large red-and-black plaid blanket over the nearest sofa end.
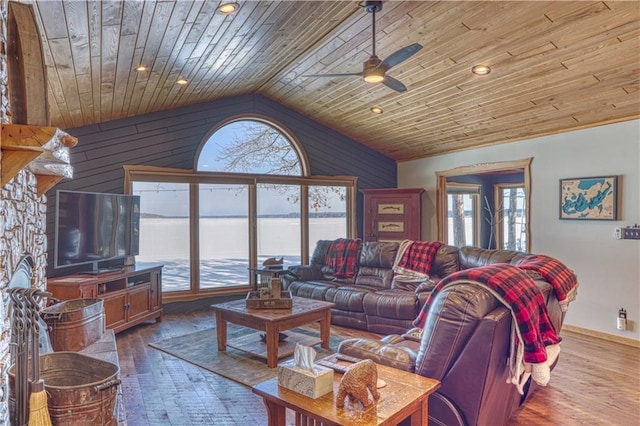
[414,263,561,363]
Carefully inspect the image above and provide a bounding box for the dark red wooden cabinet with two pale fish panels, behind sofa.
[360,188,424,241]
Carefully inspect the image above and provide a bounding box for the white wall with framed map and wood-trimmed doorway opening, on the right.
[398,120,640,340]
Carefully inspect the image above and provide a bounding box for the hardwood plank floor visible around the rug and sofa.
[117,310,640,426]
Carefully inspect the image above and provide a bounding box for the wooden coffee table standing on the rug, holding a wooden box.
[211,297,335,368]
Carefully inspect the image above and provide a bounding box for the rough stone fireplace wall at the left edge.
[0,0,47,425]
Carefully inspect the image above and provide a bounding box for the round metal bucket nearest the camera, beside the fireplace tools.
[9,352,120,426]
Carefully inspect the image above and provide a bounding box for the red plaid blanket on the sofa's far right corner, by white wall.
[516,254,578,311]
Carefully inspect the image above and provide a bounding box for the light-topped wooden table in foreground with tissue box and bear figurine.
[253,361,440,426]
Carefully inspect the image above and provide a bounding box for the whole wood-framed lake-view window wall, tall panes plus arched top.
[125,119,356,301]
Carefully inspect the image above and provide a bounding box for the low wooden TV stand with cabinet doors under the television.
[47,265,162,333]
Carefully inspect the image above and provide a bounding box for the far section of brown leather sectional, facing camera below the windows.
[283,240,459,334]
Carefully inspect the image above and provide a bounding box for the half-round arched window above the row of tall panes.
[196,119,307,176]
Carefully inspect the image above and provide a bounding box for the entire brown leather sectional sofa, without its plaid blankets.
[287,242,564,426]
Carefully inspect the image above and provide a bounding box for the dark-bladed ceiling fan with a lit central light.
[302,1,422,92]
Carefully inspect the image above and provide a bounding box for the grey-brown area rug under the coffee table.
[149,324,342,387]
